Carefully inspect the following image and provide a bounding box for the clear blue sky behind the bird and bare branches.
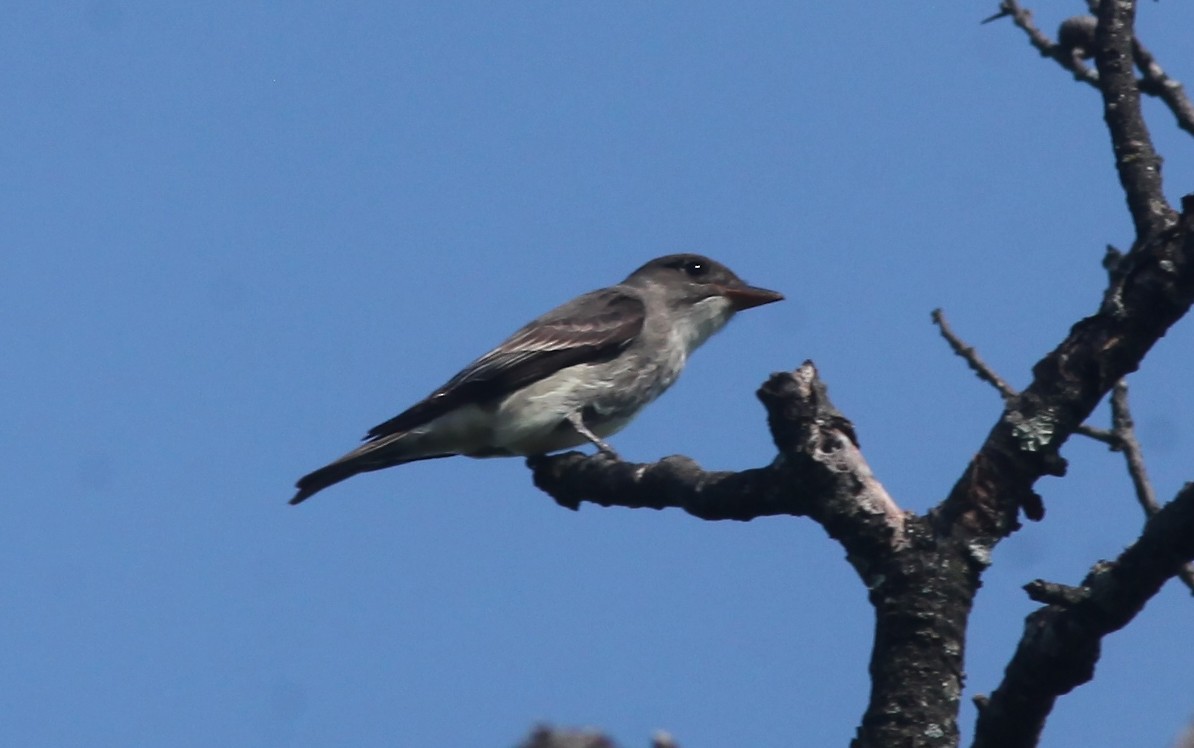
[0,0,1194,748]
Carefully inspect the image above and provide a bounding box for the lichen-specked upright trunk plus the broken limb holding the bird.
[529,363,974,748]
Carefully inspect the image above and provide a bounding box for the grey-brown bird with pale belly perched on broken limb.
[290,255,783,504]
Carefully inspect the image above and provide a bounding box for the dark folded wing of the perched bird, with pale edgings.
[365,287,646,441]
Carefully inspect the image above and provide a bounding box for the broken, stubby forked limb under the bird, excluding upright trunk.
[527,362,904,572]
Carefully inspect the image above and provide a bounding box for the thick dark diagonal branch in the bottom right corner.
[974,483,1194,748]
